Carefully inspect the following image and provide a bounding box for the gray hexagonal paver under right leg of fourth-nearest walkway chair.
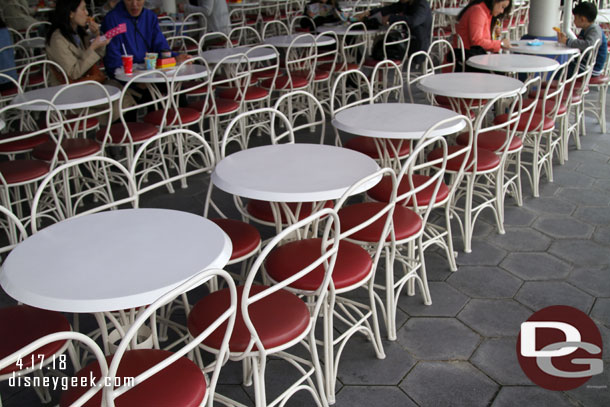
[398,282,468,317]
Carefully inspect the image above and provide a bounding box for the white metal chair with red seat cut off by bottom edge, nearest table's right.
[59,269,237,407]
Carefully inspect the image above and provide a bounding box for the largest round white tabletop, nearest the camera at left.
[0,209,232,312]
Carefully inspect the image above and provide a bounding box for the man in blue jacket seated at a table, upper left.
[102,0,190,77]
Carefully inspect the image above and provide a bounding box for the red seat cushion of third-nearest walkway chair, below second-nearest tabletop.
[265,238,373,291]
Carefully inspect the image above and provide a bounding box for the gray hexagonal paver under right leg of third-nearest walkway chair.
[334,335,417,385]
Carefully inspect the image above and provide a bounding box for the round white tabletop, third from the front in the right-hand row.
[332,103,466,139]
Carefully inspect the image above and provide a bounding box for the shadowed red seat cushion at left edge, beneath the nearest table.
[0,305,71,375]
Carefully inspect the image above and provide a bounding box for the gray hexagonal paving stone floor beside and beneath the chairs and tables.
[0,91,610,407]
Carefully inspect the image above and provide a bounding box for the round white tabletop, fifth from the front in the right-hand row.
[466,54,559,73]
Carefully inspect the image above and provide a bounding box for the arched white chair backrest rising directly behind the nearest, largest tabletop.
[31,156,138,233]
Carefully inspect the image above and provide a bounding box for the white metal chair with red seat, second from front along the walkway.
[188,209,339,407]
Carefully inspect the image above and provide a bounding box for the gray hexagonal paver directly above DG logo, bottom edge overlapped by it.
[515,281,594,314]
